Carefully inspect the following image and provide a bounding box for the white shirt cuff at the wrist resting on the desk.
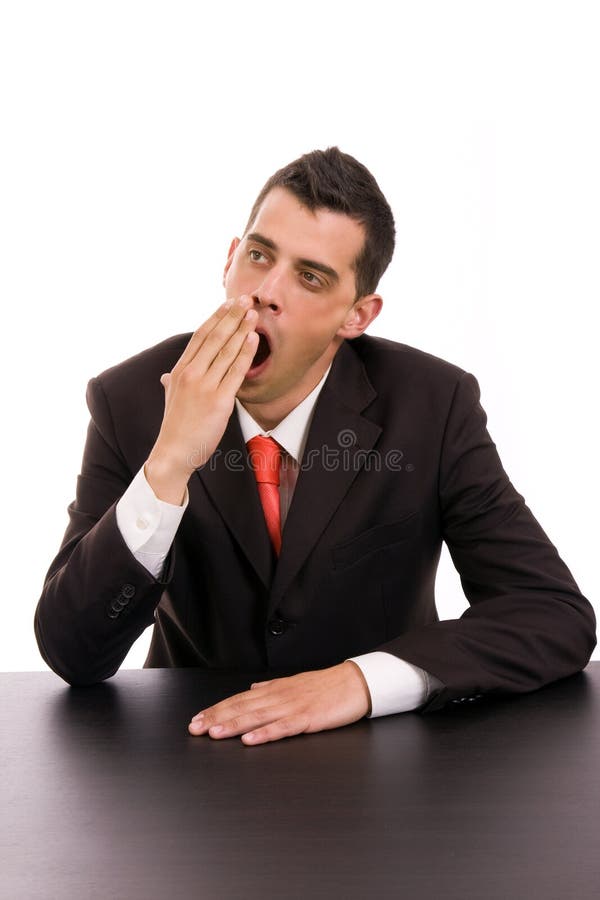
[350,650,443,719]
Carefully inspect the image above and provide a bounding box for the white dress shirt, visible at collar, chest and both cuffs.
[116,369,442,717]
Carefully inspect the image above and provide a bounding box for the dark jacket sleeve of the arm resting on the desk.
[378,373,596,710]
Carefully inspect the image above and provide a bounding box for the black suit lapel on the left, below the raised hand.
[196,411,274,588]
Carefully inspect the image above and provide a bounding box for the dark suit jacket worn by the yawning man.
[35,335,595,708]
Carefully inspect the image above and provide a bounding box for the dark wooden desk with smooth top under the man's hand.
[0,663,600,900]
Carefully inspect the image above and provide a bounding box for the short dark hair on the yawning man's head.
[244,147,396,299]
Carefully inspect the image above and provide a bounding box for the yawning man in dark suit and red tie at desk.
[35,148,595,744]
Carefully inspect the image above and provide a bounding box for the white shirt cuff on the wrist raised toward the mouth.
[116,466,189,578]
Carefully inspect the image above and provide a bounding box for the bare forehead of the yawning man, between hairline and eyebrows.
[248,187,365,274]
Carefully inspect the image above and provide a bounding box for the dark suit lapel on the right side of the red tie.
[272,344,381,606]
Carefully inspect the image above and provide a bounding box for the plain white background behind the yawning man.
[0,0,600,670]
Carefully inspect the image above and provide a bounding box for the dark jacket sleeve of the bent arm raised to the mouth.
[34,379,174,684]
